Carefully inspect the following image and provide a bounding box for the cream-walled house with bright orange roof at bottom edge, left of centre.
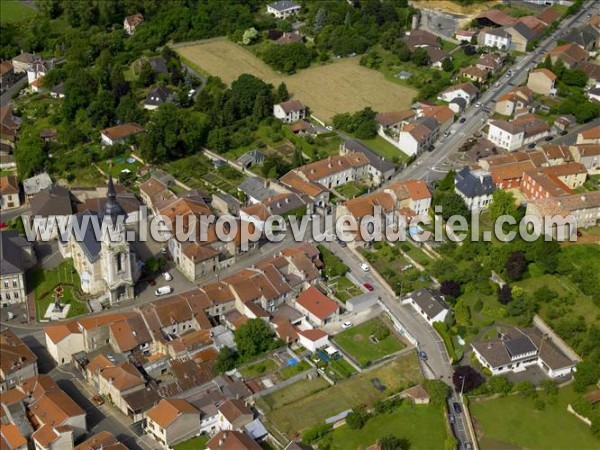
[145,398,200,448]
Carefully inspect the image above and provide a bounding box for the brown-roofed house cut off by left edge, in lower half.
[0,328,38,392]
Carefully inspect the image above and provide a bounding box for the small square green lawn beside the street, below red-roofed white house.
[333,318,406,367]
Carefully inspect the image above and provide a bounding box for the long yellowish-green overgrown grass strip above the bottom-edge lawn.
[261,354,421,433]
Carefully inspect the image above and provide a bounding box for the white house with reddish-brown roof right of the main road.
[487,114,550,151]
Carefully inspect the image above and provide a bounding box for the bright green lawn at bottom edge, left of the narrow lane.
[323,401,446,450]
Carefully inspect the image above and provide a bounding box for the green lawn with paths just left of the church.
[28,259,88,321]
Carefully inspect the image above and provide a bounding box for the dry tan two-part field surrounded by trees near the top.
[176,38,416,120]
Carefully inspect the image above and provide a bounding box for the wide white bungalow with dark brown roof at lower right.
[471,327,578,378]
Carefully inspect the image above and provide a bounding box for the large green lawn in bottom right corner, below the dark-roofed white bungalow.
[470,386,600,450]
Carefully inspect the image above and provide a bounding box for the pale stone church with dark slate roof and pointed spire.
[60,177,141,305]
